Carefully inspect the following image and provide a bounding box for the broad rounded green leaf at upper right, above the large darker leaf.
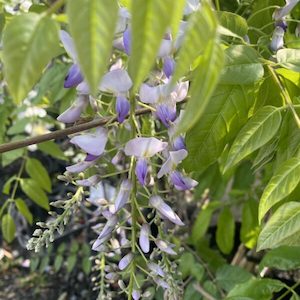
[220,45,264,84]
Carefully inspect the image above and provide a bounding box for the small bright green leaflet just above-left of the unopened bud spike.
[21,179,50,210]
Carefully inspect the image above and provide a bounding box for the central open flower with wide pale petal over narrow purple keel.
[124,137,168,186]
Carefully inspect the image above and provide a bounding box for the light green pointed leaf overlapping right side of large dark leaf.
[224,106,281,173]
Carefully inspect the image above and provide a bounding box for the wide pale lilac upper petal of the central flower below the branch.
[124,137,168,157]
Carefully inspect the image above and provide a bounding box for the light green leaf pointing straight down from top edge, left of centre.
[67,0,119,94]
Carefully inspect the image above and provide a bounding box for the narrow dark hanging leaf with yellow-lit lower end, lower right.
[240,200,260,249]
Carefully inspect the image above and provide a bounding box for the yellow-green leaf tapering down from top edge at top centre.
[129,0,178,90]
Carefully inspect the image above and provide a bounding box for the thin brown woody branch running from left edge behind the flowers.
[0,108,151,153]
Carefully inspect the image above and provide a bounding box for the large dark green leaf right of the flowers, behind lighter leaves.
[184,85,255,172]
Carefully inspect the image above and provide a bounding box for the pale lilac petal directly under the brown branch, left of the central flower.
[70,127,107,156]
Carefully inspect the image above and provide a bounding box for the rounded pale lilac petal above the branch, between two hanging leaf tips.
[99,69,132,95]
